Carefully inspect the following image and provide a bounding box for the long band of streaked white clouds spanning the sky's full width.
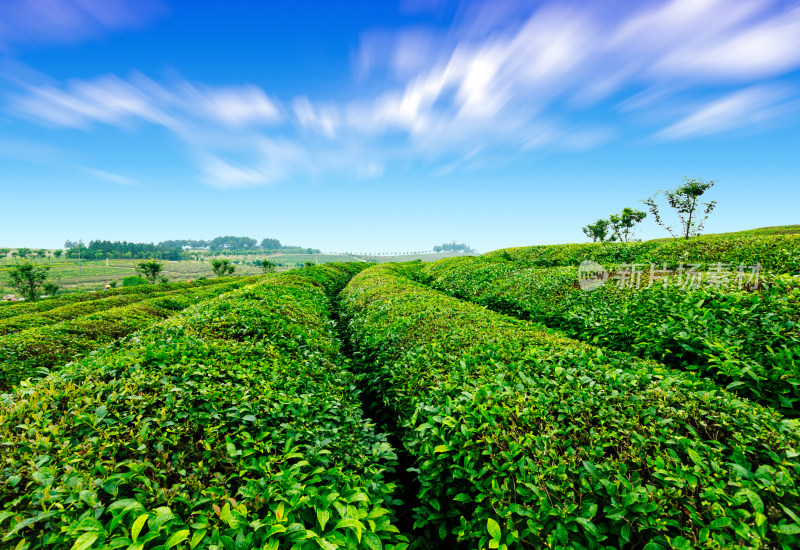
[4,0,800,188]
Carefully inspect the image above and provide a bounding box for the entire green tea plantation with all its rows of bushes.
[0,234,800,550]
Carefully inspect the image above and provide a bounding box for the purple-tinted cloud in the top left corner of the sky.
[0,0,166,50]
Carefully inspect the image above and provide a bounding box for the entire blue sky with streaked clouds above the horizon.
[0,0,800,252]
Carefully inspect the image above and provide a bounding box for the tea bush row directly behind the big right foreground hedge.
[424,258,800,417]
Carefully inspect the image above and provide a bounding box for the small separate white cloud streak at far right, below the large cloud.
[657,86,793,140]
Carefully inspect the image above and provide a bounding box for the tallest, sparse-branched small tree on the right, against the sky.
[642,177,717,239]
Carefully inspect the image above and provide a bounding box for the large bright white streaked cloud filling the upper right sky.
[346,0,800,143]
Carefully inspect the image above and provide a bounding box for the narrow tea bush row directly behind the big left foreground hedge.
[0,278,255,391]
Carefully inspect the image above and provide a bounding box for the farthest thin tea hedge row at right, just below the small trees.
[484,235,800,274]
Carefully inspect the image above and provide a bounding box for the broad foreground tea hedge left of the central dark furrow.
[0,266,407,550]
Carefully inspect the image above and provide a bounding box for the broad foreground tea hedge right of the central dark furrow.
[341,265,800,550]
